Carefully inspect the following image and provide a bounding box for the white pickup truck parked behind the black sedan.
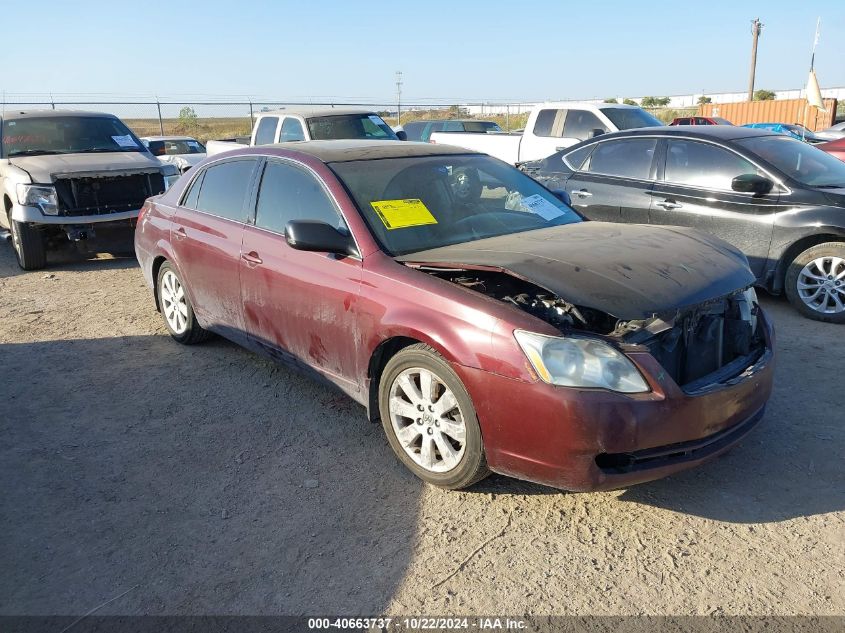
[430,102,663,165]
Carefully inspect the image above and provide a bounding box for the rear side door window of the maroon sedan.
[195,158,256,222]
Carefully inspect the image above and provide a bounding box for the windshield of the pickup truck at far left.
[2,116,145,158]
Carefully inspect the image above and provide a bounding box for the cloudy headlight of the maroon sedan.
[513,330,649,393]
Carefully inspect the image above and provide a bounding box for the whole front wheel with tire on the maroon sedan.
[379,343,490,490]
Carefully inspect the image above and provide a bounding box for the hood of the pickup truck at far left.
[9,152,161,183]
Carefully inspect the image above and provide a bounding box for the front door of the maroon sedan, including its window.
[240,160,362,395]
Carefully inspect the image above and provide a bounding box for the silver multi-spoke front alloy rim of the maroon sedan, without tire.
[388,367,466,473]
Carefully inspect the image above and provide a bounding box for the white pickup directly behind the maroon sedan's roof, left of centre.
[206,107,400,155]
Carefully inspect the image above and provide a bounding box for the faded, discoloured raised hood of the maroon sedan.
[396,222,755,320]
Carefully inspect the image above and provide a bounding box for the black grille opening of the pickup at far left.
[55,172,164,216]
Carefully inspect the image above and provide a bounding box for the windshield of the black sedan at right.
[737,136,845,187]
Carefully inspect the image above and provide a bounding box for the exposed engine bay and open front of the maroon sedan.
[419,267,764,391]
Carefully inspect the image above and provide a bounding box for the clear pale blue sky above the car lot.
[0,0,845,102]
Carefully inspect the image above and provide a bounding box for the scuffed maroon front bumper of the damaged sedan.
[455,311,774,491]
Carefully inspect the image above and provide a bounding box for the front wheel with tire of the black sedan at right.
[785,242,845,323]
